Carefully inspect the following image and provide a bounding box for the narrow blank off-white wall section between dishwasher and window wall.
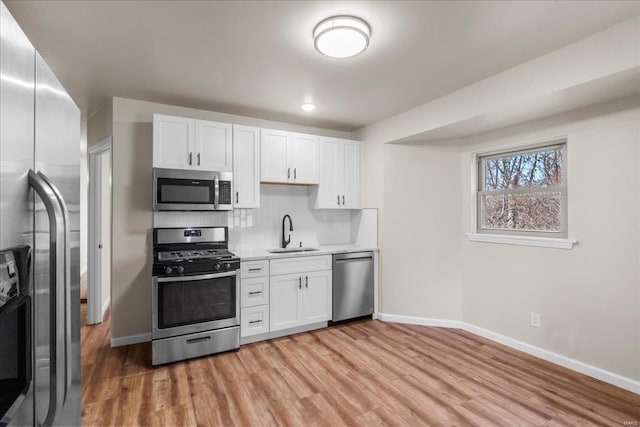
[381,145,462,320]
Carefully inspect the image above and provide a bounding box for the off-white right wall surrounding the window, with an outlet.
[460,98,640,380]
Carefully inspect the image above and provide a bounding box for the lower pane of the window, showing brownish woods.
[480,192,562,232]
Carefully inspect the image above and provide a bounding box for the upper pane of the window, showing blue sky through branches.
[482,147,562,191]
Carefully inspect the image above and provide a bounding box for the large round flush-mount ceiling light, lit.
[313,16,371,58]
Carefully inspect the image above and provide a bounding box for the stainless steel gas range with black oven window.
[151,227,240,365]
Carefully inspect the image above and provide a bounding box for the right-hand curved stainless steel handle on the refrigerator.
[38,172,72,402]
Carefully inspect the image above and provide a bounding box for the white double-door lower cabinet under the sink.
[269,256,332,332]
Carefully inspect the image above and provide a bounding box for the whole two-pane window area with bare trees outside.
[478,143,566,234]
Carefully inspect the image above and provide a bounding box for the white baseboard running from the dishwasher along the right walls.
[378,313,640,394]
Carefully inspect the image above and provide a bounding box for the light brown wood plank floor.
[82,304,640,426]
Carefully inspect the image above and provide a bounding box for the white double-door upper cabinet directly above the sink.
[260,129,319,184]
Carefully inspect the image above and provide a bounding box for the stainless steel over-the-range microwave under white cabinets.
[153,168,233,211]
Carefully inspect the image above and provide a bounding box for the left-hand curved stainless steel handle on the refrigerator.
[28,170,65,425]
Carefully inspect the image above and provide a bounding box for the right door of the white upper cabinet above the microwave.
[194,120,233,172]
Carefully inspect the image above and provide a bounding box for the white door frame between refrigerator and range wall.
[87,137,113,325]
